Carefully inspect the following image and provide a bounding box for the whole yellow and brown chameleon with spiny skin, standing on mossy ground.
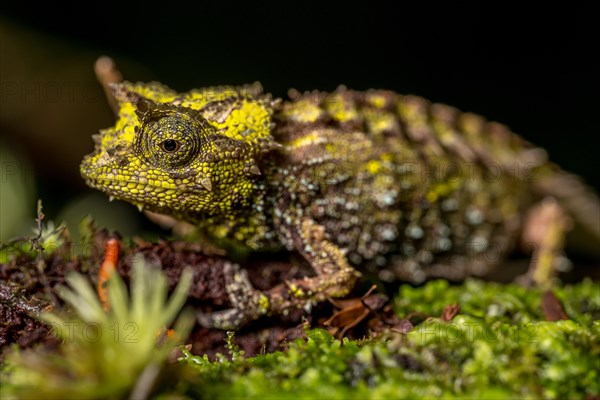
[81,75,600,329]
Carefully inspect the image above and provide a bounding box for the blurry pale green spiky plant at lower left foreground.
[1,258,193,398]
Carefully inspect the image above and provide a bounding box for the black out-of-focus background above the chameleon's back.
[0,1,600,236]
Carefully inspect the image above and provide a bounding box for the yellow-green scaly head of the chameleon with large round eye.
[80,82,278,219]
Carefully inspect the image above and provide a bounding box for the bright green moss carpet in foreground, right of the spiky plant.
[172,280,600,399]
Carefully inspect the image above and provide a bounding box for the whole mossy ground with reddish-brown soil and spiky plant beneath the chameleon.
[0,217,600,399]
